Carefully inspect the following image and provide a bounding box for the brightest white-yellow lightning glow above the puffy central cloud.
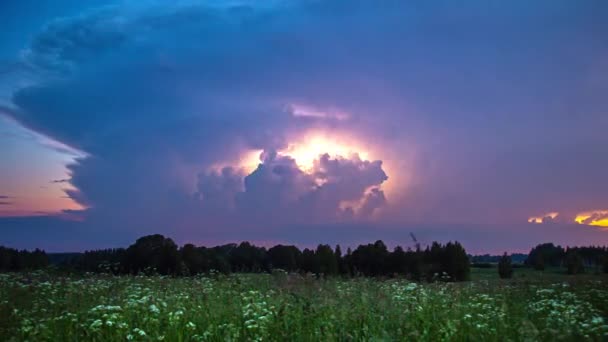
[279,134,369,171]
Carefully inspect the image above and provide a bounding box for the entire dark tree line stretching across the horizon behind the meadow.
[0,238,608,281]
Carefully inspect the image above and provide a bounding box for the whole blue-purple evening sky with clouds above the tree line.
[0,0,608,253]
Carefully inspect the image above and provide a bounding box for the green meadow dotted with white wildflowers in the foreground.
[0,269,608,341]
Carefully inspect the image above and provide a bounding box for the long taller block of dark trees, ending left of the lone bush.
[52,234,470,281]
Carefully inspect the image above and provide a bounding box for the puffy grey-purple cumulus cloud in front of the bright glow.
[197,150,387,226]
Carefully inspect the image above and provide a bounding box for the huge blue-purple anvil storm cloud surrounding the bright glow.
[1,1,608,248]
